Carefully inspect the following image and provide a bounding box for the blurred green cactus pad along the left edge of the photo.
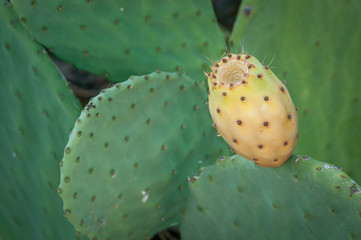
[0,1,80,240]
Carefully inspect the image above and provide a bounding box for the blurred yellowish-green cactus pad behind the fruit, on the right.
[231,0,361,182]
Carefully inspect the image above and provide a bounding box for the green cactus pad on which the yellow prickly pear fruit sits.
[181,155,361,240]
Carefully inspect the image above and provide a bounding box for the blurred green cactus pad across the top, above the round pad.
[12,0,224,81]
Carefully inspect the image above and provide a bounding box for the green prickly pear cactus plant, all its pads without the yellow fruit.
[0,0,361,240]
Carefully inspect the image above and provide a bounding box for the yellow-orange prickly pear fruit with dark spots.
[206,53,298,167]
